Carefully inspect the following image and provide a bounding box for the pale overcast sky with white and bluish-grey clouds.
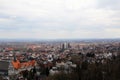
[0,0,120,39]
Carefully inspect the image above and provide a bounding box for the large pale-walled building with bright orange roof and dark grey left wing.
[0,59,36,79]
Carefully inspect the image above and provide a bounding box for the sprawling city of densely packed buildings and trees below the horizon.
[0,40,120,80]
